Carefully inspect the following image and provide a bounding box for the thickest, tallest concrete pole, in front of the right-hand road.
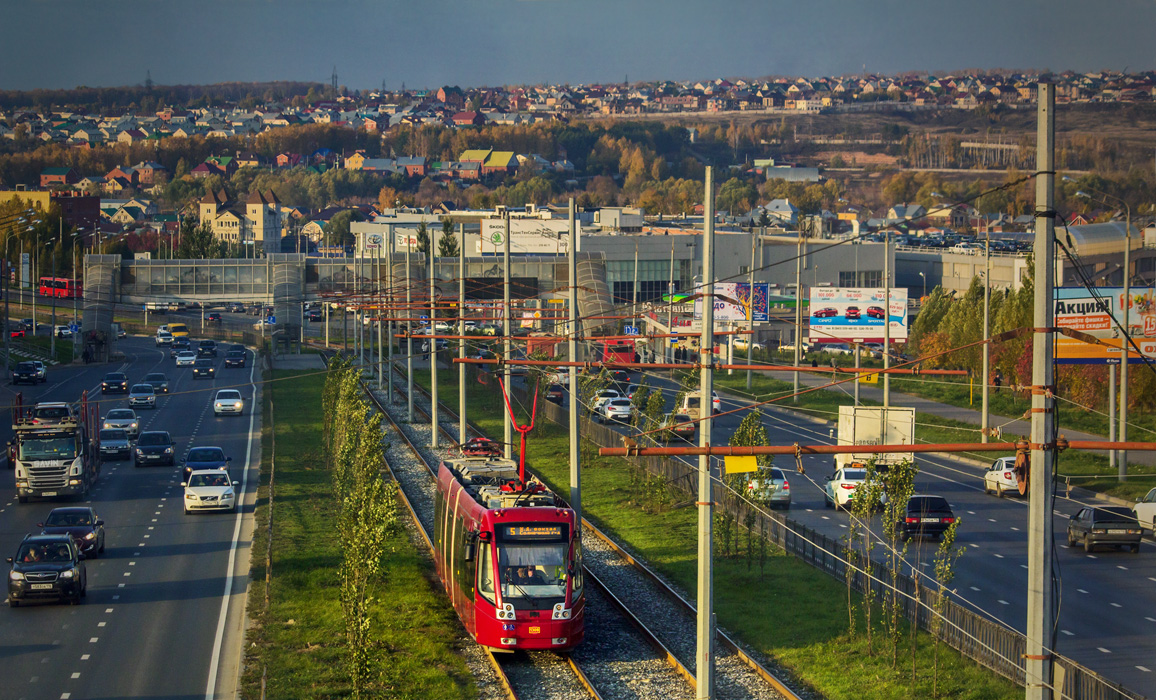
[1024,83,1055,700]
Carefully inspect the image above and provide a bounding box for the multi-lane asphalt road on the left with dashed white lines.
[0,338,260,700]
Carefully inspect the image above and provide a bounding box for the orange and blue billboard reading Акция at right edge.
[1053,286,1156,365]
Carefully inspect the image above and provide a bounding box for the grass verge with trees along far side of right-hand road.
[714,372,1156,500]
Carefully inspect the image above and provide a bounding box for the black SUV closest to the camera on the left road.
[7,535,88,608]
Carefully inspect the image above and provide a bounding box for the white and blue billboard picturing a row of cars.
[807,286,907,343]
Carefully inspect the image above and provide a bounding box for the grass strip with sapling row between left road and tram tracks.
[243,371,476,699]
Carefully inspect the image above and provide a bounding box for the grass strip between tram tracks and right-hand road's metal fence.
[415,371,1023,700]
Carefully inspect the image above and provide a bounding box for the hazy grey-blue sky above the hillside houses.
[0,0,1156,89]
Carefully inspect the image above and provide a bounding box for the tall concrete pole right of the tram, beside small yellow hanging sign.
[695,167,714,700]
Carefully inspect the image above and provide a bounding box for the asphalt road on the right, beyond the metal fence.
[591,375,1156,694]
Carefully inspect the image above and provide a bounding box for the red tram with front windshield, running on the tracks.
[434,457,586,651]
